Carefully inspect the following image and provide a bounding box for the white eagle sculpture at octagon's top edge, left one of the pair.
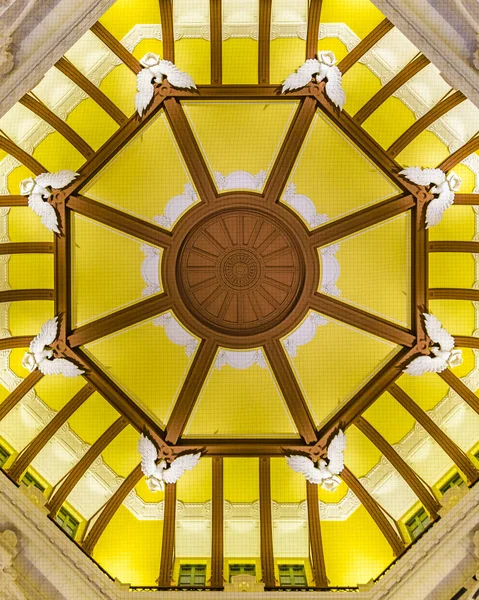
[135,52,196,117]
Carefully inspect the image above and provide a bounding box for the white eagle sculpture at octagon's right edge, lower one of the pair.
[404,313,463,375]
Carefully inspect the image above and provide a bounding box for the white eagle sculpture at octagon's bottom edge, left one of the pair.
[138,433,201,492]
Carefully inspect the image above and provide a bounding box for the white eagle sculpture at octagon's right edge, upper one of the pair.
[399,167,462,229]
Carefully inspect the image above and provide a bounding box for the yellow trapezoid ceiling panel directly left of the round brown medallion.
[72,214,162,326]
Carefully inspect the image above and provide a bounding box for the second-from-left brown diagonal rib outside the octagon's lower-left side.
[8,384,95,482]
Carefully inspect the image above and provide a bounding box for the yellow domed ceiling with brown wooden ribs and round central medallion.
[0,0,479,589]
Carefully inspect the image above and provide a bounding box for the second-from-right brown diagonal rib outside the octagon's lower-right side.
[388,383,479,483]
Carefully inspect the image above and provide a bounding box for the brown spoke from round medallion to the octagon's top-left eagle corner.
[164,98,216,202]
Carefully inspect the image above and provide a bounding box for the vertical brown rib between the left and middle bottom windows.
[211,456,224,587]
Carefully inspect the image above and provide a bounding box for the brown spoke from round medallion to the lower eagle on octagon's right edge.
[310,292,415,347]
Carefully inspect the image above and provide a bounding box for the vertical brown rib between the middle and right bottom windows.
[259,456,276,587]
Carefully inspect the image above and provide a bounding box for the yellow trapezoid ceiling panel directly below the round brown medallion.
[185,351,297,438]
